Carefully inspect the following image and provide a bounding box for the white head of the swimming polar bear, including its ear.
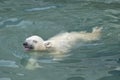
[23,35,51,51]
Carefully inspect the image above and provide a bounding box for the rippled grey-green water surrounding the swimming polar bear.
[0,0,120,80]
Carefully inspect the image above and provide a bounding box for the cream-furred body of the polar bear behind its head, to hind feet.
[48,27,102,53]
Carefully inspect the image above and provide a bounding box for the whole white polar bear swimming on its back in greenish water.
[23,27,102,69]
